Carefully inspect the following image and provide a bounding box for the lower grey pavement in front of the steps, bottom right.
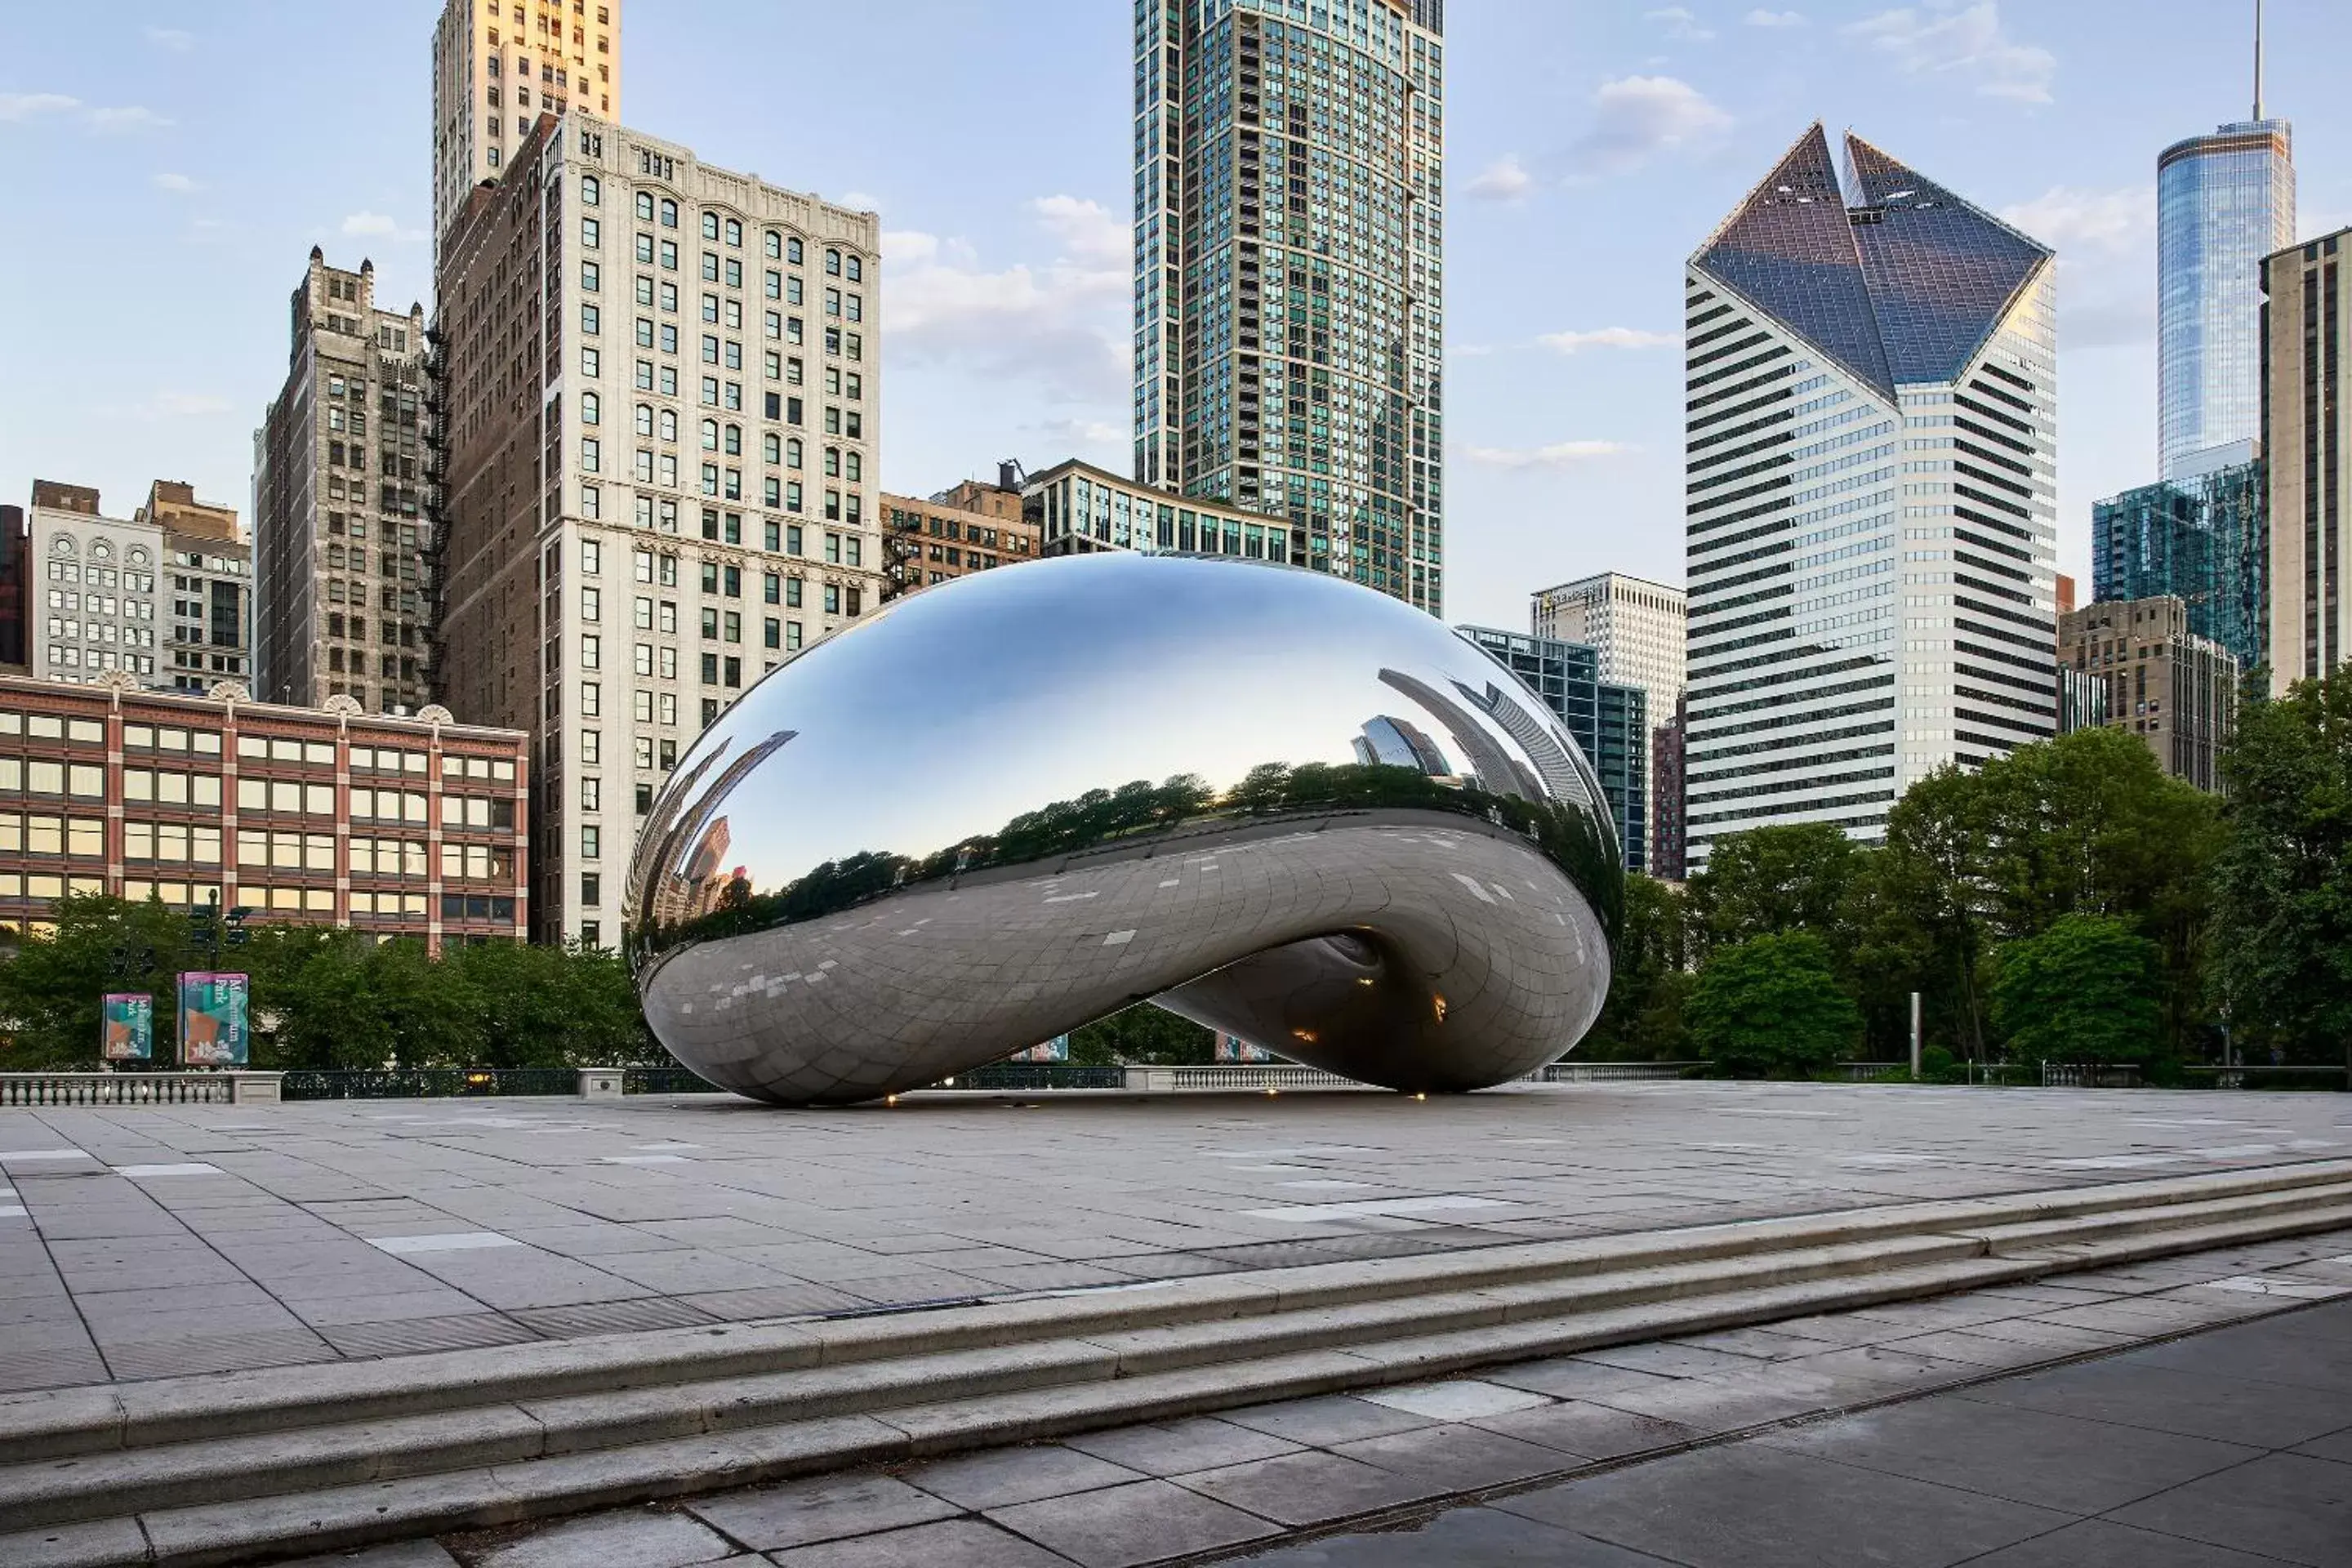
[332,1232,2352,1568]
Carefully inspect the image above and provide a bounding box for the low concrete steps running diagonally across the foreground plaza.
[0,1161,2352,1563]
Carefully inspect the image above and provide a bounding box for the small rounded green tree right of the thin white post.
[1992,915,2164,1062]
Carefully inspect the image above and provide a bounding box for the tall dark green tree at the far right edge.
[2208,670,2352,1065]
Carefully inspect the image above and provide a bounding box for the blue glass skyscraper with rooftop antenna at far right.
[2157,5,2296,479]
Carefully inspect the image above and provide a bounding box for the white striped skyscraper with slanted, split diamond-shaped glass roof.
[1684,125,2058,872]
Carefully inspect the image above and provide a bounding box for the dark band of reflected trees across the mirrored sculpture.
[635,762,1625,957]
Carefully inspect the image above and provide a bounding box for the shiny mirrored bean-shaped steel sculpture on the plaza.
[628,552,1623,1105]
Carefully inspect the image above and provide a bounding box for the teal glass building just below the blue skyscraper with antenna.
[2097,458,2270,670]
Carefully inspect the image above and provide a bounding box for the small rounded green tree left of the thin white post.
[1684,931,1863,1076]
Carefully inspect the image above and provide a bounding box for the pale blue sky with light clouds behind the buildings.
[0,0,2352,628]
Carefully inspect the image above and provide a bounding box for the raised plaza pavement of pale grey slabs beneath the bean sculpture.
[0,1084,2352,1392]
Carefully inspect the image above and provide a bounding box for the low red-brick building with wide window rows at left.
[0,670,527,950]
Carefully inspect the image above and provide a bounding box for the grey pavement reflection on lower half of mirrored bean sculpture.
[647,811,1609,1102]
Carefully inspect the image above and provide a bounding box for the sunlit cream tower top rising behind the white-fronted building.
[433,0,621,244]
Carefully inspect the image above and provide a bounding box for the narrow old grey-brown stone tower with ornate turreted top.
[254,247,430,712]
